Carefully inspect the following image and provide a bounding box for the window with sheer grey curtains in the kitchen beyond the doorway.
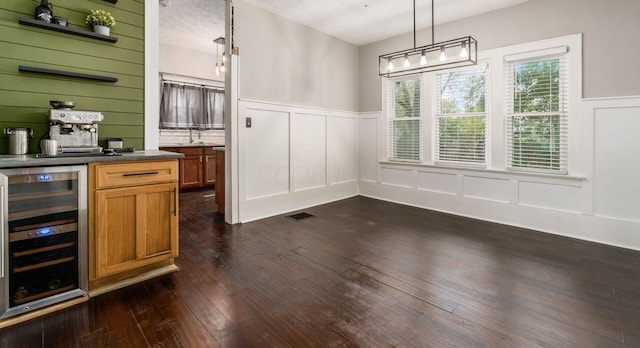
[160,81,224,129]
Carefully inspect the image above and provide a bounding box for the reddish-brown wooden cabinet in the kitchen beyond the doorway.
[160,146,216,189]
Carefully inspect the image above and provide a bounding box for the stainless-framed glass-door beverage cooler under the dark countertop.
[0,166,88,318]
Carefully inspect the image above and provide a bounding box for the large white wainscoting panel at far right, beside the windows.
[594,107,640,223]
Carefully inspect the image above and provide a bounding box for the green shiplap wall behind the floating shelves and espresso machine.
[0,0,144,154]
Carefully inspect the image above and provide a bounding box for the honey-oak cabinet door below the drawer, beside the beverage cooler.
[95,183,178,277]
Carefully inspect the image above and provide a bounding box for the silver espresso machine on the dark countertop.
[49,103,104,153]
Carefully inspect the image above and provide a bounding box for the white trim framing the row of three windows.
[380,34,584,179]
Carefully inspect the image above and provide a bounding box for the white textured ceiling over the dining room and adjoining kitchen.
[160,0,528,52]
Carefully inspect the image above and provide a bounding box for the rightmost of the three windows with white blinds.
[505,48,568,174]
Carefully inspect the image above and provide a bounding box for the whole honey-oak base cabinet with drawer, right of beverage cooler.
[89,160,178,288]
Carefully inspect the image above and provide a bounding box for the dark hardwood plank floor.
[0,191,640,347]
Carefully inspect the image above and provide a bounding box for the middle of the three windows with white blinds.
[435,64,489,165]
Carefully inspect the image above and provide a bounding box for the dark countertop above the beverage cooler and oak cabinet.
[0,150,184,168]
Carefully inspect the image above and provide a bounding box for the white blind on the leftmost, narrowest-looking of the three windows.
[387,77,422,161]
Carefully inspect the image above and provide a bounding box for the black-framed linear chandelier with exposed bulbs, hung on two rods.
[379,0,478,77]
